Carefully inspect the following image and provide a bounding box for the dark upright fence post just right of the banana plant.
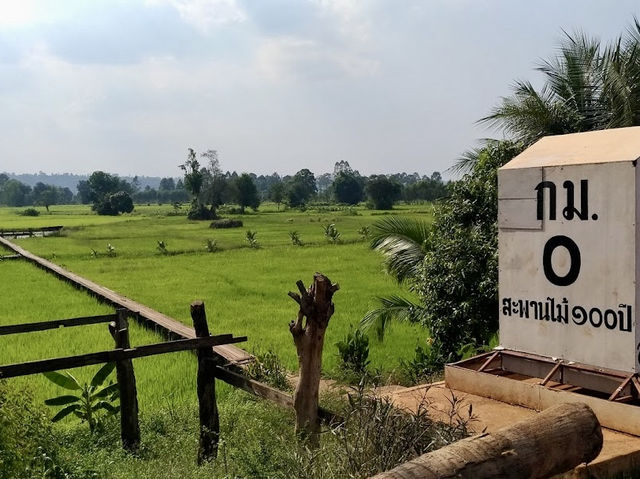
[109,309,140,452]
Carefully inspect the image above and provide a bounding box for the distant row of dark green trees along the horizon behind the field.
[0,160,448,218]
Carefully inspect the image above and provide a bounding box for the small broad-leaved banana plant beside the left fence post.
[43,363,120,432]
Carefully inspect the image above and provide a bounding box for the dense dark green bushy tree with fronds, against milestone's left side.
[363,141,523,368]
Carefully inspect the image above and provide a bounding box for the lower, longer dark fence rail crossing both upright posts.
[0,334,247,379]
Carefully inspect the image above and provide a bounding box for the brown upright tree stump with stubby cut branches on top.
[289,273,340,446]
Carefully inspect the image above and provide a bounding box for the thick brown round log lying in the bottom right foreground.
[374,403,602,479]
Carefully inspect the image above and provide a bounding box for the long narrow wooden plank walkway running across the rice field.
[0,235,253,365]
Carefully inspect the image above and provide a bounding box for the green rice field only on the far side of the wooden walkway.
[0,205,431,374]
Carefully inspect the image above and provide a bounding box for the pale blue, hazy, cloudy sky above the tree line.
[0,0,640,177]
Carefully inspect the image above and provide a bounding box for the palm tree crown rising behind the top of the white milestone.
[478,22,640,154]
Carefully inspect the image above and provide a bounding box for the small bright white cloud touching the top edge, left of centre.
[147,0,246,33]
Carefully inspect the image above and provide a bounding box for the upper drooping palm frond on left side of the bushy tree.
[371,216,430,283]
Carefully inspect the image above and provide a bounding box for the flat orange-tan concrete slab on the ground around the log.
[389,378,640,479]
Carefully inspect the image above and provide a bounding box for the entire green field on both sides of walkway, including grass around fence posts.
[0,205,438,479]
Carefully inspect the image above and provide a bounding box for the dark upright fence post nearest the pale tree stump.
[191,301,220,464]
